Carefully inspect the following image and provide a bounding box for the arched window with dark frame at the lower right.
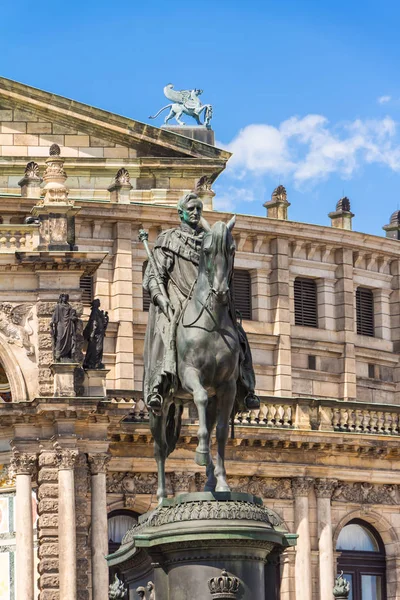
[336,519,386,600]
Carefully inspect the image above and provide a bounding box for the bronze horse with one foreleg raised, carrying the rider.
[150,217,239,500]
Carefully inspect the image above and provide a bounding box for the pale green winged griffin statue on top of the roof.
[149,83,212,129]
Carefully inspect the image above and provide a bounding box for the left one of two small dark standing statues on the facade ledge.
[50,294,78,363]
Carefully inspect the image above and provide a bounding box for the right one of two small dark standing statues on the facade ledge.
[83,298,109,369]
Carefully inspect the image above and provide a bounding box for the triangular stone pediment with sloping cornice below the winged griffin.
[0,77,230,162]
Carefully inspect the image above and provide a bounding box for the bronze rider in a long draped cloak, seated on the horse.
[143,192,260,412]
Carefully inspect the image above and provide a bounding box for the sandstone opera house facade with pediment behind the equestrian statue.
[0,78,400,600]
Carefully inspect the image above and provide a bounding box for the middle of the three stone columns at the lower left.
[56,446,78,600]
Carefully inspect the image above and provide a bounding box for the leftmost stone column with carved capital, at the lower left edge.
[11,450,36,600]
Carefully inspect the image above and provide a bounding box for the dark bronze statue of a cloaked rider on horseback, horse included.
[139,193,260,500]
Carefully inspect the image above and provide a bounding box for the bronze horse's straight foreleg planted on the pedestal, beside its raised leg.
[214,380,236,492]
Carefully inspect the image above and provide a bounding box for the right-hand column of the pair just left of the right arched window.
[315,479,337,600]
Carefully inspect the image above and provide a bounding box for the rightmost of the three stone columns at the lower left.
[89,454,110,600]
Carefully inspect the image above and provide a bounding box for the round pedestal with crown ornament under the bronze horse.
[108,492,296,600]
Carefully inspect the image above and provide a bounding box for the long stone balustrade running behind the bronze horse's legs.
[109,391,400,458]
